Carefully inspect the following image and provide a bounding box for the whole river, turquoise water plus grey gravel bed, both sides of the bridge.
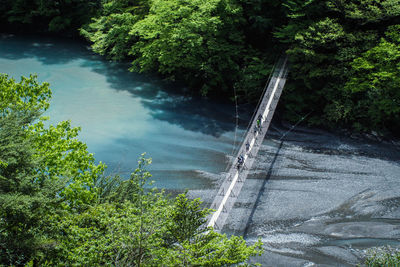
[0,35,400,266]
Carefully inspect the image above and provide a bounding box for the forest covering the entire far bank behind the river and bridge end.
[0,0,400,135]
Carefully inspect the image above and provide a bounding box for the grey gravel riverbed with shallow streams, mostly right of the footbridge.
[190,124,400,266]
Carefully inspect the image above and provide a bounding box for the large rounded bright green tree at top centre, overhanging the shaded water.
[130,0,244,94]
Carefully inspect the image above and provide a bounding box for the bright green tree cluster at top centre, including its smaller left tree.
[82,0,253,94]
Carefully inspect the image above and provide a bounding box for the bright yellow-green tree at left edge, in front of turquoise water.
[0,74,104,265]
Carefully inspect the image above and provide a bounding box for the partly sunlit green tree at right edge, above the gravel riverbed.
[344,25,400,132]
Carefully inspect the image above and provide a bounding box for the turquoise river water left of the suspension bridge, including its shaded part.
[0,35,242,189]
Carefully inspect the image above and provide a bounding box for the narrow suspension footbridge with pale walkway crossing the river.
[207,58,288,230]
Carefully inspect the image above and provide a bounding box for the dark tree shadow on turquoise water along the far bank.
[0,34,241,137]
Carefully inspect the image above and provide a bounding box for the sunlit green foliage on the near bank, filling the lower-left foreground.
[0,74,261,266]
